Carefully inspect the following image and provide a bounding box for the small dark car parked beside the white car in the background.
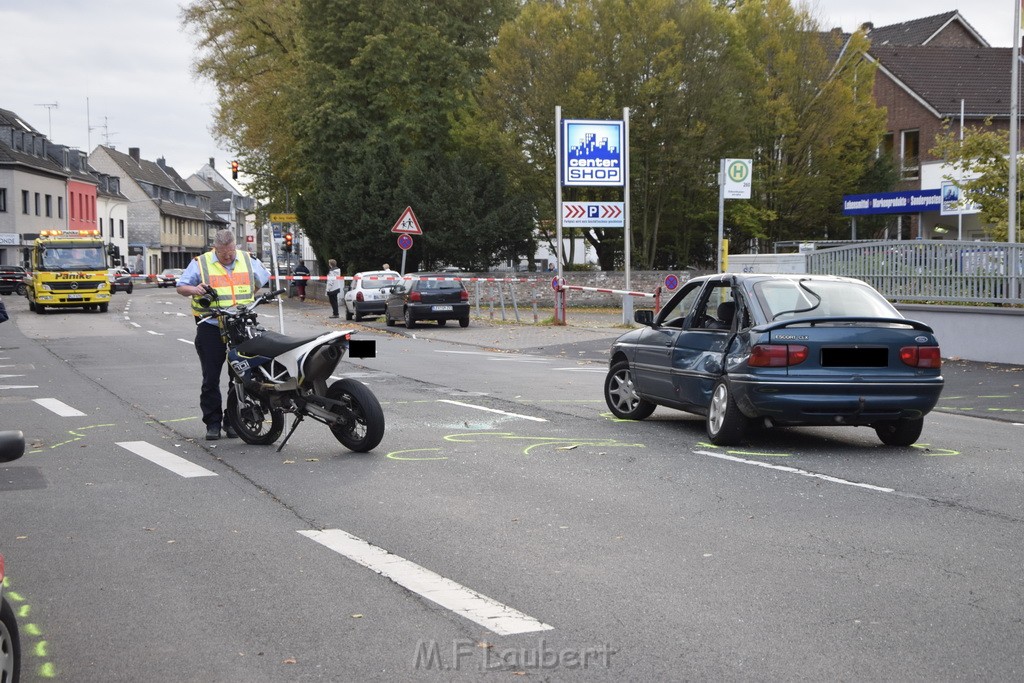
[384,272,469,330]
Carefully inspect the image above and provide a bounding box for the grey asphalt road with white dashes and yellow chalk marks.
[0,289,1024,681]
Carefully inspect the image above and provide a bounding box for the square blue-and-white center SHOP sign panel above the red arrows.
[561,119,626,186]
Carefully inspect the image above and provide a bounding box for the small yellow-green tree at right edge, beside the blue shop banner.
[932,120,1024,242]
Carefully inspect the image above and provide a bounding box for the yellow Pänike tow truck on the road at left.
[25,229,111,313]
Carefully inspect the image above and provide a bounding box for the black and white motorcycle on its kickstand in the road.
[198,289,384,453]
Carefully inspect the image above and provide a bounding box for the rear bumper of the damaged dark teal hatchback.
[730,377,943,425]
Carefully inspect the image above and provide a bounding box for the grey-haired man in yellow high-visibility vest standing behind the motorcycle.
[177,229,270,441]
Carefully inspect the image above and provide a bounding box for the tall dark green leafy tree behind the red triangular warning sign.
[290,0,534,271]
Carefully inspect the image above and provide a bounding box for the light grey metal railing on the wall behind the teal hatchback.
[807,240,1024,304]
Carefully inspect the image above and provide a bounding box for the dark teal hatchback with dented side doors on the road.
[604,273,943,446]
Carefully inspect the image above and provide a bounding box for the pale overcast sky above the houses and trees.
[0,0,1016,177]
